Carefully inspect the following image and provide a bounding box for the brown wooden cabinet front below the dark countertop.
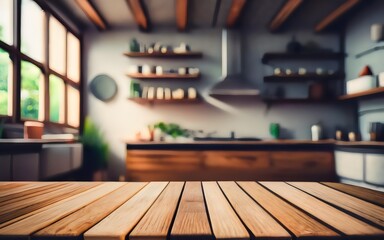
[126,150,335,181]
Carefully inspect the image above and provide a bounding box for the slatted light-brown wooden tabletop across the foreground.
[0,182,384,240]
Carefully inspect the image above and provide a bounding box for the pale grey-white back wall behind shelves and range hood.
[84,29,354,178]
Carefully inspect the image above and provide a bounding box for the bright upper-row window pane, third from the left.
[49,17,66,75]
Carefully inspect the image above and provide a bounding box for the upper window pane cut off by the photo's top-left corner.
[0,0,13,45]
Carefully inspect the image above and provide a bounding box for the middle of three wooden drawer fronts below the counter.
[204,151,269,170]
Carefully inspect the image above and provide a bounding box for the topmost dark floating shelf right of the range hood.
[261,52,345,64]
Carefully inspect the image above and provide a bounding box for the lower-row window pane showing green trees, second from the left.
[20,61,44,120]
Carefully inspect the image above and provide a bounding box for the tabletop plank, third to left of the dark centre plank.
[34,183,147,239]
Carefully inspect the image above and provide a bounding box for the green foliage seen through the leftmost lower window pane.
[0,47,10,115]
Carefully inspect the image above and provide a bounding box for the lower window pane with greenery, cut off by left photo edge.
[0,48,12,116]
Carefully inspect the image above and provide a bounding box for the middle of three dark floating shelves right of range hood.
[264,74,344,82]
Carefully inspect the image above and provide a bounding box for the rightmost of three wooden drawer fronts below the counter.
[269,151,333,171]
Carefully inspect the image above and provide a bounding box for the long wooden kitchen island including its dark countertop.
[126,140,336,181]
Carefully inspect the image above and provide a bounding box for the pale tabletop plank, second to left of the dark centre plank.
[84,182,168,240]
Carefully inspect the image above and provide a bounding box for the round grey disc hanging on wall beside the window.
[89,74,117,102]
